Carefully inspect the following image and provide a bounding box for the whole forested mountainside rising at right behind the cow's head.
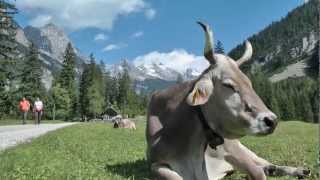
[229,0,319,122]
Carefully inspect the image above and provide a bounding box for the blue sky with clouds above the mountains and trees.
[16,0,303,64]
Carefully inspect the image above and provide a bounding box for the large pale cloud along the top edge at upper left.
[16,0,155,30]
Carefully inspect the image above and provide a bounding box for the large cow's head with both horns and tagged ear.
[187,22,277,138]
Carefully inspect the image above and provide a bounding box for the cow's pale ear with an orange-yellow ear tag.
[187,79,213,106]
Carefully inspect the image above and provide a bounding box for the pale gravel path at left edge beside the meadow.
[0,123,76,151]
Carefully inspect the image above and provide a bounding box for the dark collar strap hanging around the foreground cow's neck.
[196,106,224,149]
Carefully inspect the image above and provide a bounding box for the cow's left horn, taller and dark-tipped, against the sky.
[197,21,216,64]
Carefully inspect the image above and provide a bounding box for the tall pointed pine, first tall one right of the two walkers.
[58,43,78,118]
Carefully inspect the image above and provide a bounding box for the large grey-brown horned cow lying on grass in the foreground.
[146,22,310,180]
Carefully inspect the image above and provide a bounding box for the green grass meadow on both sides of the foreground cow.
[0,121,318,180]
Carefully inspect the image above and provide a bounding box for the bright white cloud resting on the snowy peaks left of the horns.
[133,49,209,73]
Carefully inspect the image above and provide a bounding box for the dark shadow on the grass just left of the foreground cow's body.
[105,159,150,180]
